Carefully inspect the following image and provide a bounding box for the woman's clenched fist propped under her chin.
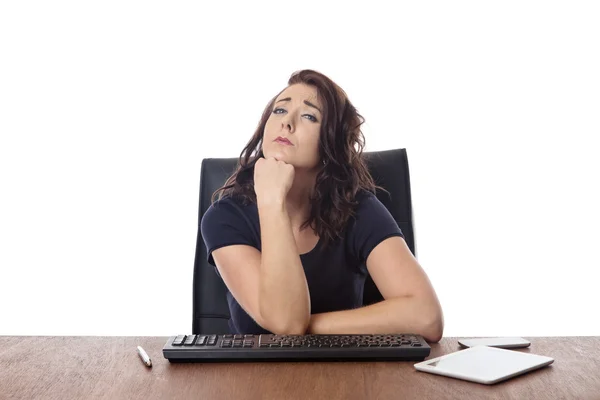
[254,157,294,204]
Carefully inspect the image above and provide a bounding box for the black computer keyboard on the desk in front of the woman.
[163,334,431,362]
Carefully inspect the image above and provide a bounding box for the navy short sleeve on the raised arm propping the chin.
[200,198,258,273]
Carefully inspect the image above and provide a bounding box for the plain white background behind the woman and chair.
[0,0,600,336]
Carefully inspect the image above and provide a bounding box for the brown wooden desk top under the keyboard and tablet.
[0,336,600,400]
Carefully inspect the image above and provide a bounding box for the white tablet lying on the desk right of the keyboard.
[415,346,554,385]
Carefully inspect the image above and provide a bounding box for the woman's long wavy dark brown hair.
[212,69,382,245]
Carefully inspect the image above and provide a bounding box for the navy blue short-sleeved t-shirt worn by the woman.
[201,192,404,334]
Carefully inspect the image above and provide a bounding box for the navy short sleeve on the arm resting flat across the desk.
[349,192,404,268]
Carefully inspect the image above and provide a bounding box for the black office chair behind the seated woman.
[192,149,416,334]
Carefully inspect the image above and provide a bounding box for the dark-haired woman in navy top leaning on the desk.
[201,70,444,342]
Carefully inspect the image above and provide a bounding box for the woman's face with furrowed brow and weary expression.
[262,83,323,169]
